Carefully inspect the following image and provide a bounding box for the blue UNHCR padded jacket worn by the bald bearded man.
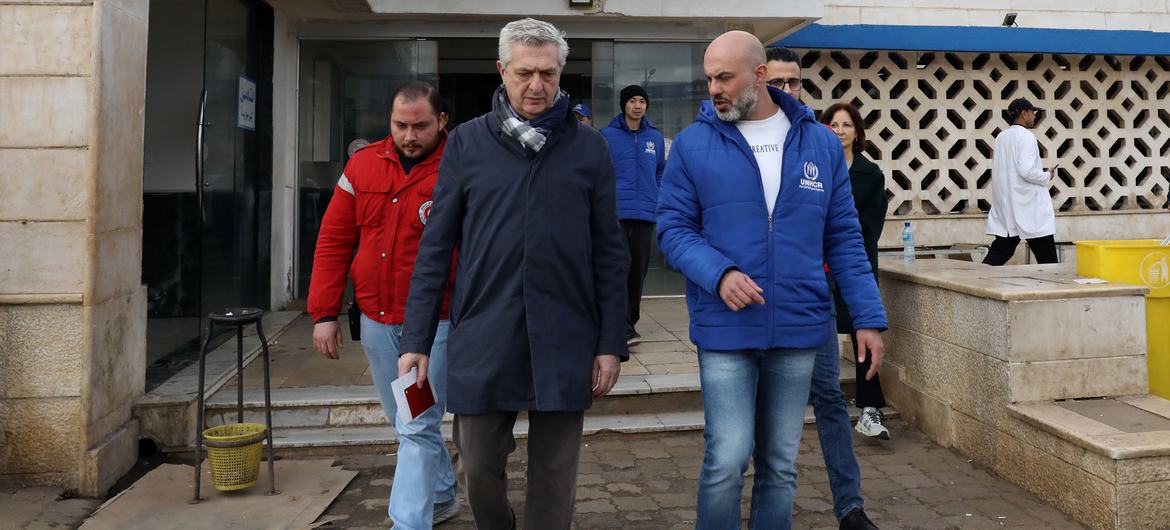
[658,88,887,350]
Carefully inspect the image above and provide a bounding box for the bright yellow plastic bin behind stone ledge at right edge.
[1076,239,1170,399]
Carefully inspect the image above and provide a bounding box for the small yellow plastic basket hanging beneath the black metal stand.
[204,424,264,491]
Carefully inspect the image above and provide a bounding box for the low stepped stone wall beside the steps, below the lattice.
[881,260,1170,530]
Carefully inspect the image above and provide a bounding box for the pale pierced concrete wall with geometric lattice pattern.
[801,49,1170,247]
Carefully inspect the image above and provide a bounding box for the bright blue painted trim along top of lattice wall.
[772,23,1170,55]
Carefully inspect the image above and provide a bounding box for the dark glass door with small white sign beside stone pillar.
[143,0,273,386]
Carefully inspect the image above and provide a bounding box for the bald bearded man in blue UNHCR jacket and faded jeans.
[658,32,887,530]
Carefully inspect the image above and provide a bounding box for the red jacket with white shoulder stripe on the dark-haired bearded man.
[308,132,454,324]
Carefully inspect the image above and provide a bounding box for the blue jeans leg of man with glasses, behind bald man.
[811,318,863,521]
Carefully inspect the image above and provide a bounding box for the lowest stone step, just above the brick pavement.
[265,406,900,456]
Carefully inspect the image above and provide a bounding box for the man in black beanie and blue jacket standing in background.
[601,84,666,346]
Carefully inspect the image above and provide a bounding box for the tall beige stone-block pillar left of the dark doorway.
[0,0,149,496]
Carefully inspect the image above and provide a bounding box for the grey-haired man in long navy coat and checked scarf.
[399,19,628,530]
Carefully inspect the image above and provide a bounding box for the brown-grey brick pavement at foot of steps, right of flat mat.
[315,420,1082,530]
